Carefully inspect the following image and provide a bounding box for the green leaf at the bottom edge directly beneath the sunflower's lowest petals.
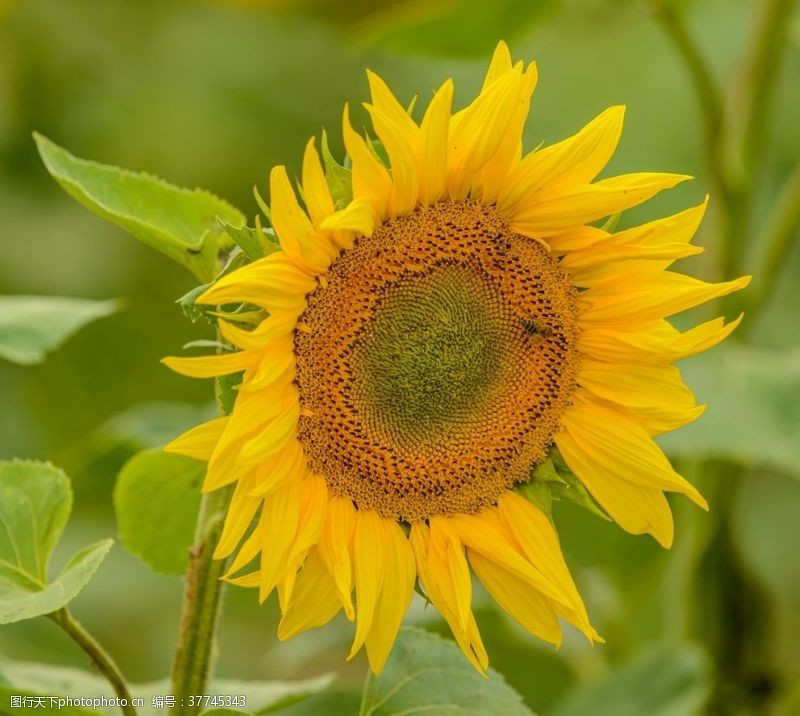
[360,627,532,716]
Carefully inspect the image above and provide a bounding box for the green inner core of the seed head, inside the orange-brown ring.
[356,266,503,446]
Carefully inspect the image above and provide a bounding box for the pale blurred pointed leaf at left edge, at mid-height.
[0,296,120,365]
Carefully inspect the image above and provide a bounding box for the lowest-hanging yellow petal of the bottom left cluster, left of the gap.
[364,522,417,674]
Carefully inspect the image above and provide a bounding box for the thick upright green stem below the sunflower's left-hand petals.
[172,489,230,716]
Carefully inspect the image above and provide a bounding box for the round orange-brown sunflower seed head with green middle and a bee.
[295,201,578,522]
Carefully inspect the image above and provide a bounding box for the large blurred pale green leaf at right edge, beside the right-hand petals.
[658,343,800,475]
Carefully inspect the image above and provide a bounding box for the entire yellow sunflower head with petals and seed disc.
[165,43,749,673]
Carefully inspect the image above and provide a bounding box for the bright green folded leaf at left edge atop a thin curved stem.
[0,460,112,624]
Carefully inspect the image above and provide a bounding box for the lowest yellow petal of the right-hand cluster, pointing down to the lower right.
[555,431,674,548]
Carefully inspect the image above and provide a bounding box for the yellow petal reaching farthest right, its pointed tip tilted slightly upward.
[579,271,750,326]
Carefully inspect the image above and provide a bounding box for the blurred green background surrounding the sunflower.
[0,0,800,716]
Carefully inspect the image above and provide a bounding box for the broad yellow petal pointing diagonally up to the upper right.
[497,106,625,213]
